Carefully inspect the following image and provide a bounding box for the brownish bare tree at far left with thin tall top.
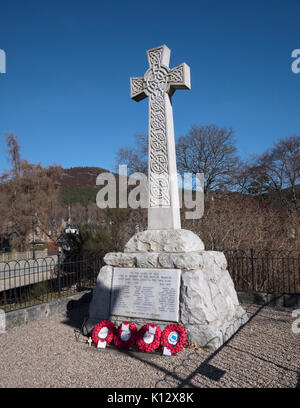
[0,134,61,250]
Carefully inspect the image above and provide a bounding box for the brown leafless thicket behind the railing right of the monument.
[182,192,299,250]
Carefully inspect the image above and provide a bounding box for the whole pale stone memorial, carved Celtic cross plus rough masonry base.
[88,45,248,350]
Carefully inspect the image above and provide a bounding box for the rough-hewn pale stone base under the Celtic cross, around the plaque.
[88,242,248,350]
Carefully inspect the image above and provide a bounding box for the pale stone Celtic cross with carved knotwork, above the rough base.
[130,45,191,230]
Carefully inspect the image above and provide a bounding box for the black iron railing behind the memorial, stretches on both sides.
[0,249,300,312]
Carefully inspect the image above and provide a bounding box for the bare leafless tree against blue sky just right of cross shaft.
[176,125,238,193]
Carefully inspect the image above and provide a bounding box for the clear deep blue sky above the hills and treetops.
[0,0,300,172]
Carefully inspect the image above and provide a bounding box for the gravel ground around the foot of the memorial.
[0,305,300,388]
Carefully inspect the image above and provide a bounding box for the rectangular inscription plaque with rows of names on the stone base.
[111,268,181,322]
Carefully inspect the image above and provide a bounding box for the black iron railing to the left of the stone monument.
[0,253,103,312]
